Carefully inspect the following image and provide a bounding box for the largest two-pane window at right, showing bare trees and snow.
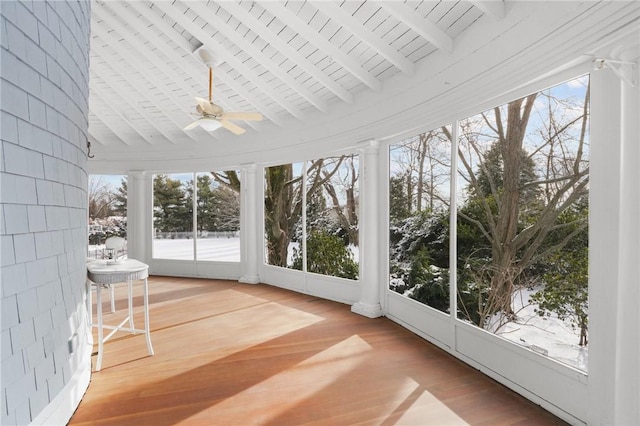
[389,76,589,371]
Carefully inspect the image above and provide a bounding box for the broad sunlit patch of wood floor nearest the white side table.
[105,298,324,388]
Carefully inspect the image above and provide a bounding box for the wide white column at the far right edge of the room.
[587,63,640,425]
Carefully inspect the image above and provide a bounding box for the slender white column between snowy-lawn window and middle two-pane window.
[238,164,262,284]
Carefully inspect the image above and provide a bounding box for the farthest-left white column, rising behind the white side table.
[127,171,151,263]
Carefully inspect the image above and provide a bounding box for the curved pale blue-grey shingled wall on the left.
[0,0,91,425]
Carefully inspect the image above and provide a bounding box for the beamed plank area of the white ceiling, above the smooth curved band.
[89,0,637,170]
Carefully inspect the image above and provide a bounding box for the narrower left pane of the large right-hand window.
[389,126,451,312]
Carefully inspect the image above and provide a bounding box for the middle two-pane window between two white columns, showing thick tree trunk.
[265,155,359,279]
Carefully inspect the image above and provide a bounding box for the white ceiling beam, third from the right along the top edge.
[311,0,415,75]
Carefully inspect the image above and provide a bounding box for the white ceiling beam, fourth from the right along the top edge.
[260,2,382,91]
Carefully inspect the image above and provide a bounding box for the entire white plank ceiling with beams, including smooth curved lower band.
[88,0,640,173]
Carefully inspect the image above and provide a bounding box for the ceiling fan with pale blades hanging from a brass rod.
[183,52,262,135]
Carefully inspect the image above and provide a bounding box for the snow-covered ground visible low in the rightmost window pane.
[488,289,589,371]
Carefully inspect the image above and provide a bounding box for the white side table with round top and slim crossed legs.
[87,259,153,371]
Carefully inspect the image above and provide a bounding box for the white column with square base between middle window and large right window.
[351,140,382,318]
